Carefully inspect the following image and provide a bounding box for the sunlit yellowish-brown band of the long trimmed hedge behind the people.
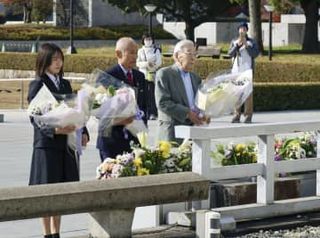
[0,53,320,83]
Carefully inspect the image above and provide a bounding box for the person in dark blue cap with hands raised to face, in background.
[228,22,259,123]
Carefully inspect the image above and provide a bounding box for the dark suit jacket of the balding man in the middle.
[97,65,147,158]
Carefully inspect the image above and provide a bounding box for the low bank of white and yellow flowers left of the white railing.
[96,138,191,179]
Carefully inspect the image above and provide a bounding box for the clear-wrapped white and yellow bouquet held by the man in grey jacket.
[195,70,252,117]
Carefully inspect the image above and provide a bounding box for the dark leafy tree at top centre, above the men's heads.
[104,0,232,40]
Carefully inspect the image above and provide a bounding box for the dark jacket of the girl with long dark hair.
[28,75,89,149]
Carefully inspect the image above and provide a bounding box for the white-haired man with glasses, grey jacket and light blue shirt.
[155,40,207,143]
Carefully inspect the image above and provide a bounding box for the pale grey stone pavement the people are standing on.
[0,110,320,238]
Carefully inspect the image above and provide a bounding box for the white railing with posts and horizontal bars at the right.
[175,121,320,219]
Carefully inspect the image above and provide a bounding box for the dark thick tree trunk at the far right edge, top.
[269,0,320,53]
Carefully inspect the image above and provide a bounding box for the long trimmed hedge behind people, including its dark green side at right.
[0,53,320,111]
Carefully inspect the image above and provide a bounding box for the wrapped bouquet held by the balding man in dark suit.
[83,69,147,137]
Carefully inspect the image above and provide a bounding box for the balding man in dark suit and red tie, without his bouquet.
[97,37,147,161]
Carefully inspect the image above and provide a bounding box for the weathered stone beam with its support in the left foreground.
[0,172,209,238]
